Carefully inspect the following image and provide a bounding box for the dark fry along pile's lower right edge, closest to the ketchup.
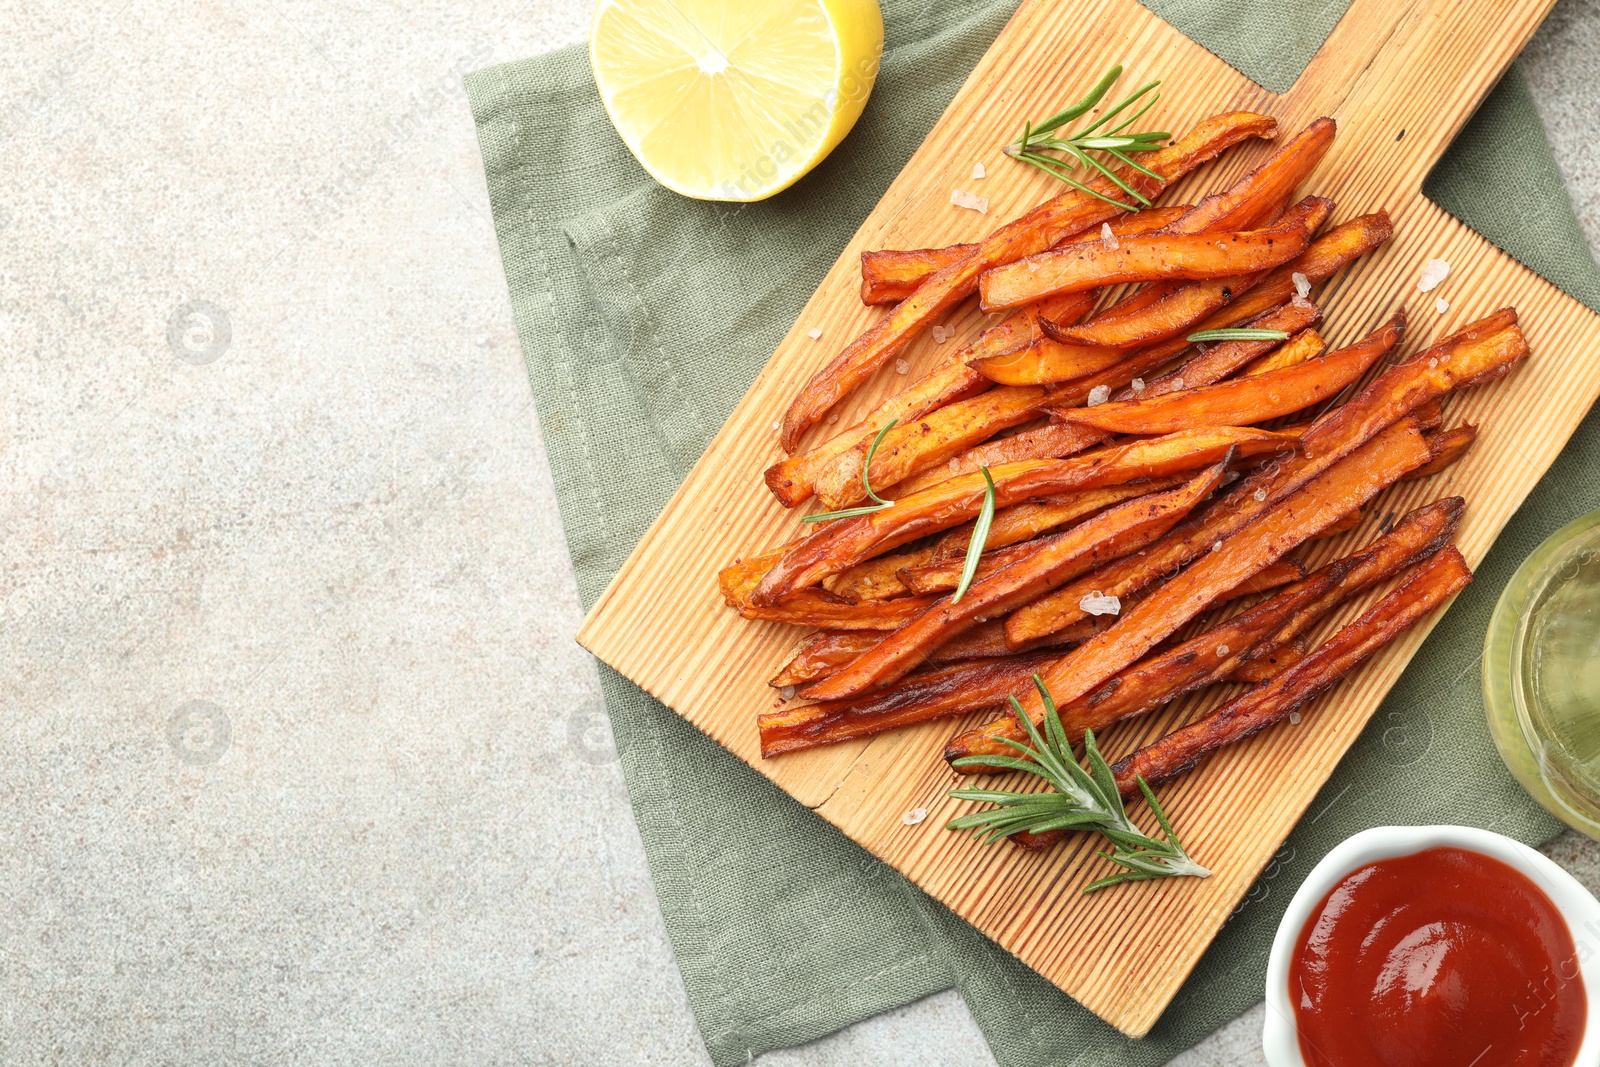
[1112,545,1472,795]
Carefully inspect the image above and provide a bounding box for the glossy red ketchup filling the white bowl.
[1290,848,1587,1067]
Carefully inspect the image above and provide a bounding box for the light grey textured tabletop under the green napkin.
[0,0,1600,1067]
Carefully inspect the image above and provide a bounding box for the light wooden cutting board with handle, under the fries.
[578,0,1600,1037]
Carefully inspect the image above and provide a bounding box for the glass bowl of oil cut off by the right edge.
[1483,510,1600,840]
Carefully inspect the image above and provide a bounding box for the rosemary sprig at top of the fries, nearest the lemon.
[1005,66,1171,211]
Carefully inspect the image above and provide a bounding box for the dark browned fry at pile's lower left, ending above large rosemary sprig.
[757,654,1068,758]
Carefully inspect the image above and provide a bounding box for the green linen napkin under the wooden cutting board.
[469,0,1600,1067]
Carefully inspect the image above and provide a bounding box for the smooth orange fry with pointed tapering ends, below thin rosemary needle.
[1051,329,1387,434]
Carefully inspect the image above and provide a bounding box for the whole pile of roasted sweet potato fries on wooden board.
[720,102,1528,870]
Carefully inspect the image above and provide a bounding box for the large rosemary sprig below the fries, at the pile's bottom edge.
[947,675,1211,893]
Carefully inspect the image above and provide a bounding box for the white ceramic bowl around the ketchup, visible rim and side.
[1261,825,1600,1067]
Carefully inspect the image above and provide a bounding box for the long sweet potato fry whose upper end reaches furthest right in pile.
[1006,309,1528,648]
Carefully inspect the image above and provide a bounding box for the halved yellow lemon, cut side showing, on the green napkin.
[589,0,883,200]
